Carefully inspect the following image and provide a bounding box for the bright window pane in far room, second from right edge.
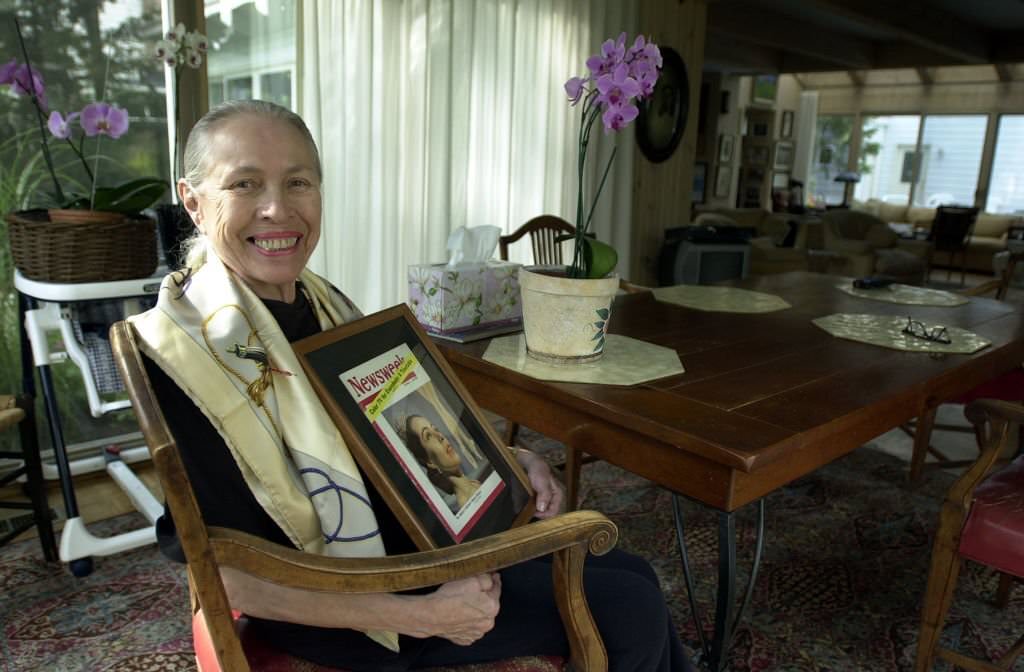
[913,115,988,208]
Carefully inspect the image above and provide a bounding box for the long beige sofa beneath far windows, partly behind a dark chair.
[851,199,1024,274]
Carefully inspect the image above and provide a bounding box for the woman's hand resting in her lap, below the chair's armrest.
[411,573,502,646]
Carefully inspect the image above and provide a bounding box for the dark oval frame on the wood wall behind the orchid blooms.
[636,47,690,163]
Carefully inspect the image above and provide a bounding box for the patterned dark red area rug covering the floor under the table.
[0,430,1024,672]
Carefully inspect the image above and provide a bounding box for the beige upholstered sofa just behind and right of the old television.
[693,208,808,275]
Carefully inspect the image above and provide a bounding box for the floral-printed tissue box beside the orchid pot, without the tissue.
[409,261,522,336]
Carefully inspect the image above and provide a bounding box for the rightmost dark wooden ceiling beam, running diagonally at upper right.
[802,0,990,65]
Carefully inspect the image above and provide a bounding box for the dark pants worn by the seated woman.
[260,550,693,672]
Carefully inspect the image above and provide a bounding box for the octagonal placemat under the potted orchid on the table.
[483,334,685,385]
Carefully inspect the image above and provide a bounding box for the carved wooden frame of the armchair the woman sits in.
[111,322,618,672]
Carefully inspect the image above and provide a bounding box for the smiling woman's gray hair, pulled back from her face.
[176,100,324,268]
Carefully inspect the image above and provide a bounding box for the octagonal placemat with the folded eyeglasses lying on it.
[811,312,992,354]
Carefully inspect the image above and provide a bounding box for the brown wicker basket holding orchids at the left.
[4,210,157,283]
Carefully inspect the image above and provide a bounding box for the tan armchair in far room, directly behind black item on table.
[821,210,932,285]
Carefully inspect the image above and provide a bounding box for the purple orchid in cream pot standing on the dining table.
[519,33,662,363]
